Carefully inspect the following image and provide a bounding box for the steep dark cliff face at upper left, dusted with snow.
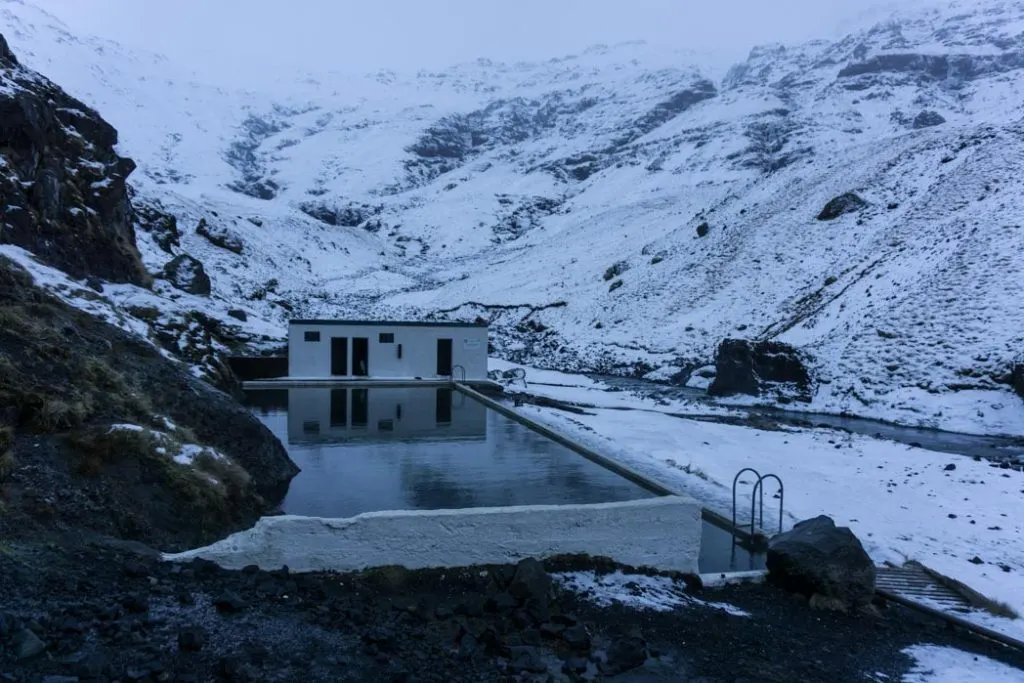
[0,36,150,285]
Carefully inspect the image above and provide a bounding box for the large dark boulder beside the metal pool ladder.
[766,515,874,609]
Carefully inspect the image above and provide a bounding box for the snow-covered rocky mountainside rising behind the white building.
[0,0,1024,432]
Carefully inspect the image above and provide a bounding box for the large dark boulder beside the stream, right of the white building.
[708,339,813,402]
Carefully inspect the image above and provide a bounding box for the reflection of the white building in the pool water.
[288,387,487,444]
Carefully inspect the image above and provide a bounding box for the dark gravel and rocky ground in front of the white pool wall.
[0,539,1024,683]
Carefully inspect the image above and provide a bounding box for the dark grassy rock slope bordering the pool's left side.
[0,258,298,550]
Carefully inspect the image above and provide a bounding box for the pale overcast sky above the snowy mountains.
[35,0,918,79]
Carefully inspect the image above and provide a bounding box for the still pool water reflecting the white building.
[241,386,655,517]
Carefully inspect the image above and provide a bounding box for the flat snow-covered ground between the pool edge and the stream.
[492,361,1024,639]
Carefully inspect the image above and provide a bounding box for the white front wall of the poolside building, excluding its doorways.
[288,324,487,380]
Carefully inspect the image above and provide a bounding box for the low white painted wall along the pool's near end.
[163,496,701,573]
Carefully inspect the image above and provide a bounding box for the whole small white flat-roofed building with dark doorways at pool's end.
[288,321,487,381]
